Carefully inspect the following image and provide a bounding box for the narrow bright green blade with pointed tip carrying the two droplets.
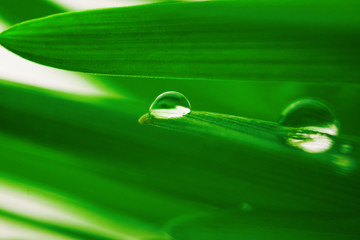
[139,111,360,161]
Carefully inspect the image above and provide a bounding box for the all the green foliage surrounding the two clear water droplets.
[0,0,360,240]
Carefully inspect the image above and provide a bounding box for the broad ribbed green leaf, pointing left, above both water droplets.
[0,1,360,83]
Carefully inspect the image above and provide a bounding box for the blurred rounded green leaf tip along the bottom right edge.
[168,209,360,240]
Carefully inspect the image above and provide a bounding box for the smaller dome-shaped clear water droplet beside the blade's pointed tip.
[149,91,191,119]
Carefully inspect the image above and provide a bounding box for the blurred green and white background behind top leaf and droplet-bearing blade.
[0,0,360,240]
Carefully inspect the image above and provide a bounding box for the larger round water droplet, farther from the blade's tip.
[279,98,339,153]
